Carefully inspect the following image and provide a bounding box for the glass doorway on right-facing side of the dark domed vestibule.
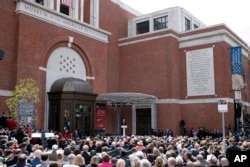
[75,104,91,136]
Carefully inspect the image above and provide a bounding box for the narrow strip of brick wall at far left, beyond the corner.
[0,0,18,112]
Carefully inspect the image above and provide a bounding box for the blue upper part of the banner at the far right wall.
[230,46,243,75]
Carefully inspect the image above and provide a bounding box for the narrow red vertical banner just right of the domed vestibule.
[96,105,106,130]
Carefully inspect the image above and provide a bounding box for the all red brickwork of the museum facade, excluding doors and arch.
[0,0,250,134]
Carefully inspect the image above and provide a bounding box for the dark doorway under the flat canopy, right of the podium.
[136,108,152,135]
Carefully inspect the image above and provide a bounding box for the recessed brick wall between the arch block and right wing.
[98,0,137,93]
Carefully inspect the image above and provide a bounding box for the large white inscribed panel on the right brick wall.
[186,48,215,96]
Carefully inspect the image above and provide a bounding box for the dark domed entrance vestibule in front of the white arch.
[48,78,97,136]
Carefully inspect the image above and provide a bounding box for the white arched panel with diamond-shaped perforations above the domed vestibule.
[44,47,91,130]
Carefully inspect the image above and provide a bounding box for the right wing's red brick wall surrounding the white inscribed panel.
[119,26,249,134]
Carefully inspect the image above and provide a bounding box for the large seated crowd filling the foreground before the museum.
[0,112,250,167]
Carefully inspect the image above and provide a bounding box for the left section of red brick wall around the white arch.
[0,0,138,128]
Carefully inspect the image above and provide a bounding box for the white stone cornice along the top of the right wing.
[118,25,250,58]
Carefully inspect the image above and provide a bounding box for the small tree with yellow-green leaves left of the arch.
[6,78,40,126]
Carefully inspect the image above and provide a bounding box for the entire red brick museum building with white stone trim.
[0,0,249,135]
